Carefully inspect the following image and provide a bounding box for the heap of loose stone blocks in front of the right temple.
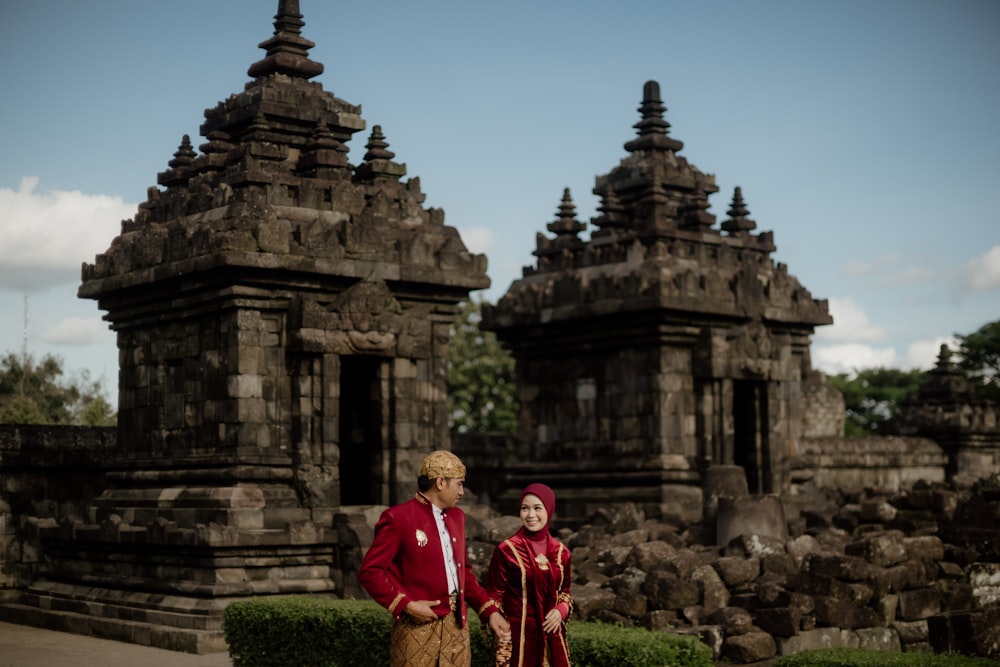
[456,485,1000,663]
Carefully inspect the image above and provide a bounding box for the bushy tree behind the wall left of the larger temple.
[0,352,116,426]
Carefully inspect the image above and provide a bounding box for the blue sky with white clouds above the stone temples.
[0,0,1000,395]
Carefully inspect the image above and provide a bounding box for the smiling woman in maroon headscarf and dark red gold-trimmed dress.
[486,484,573,667]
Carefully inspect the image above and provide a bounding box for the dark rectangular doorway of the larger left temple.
[339,356,383,505]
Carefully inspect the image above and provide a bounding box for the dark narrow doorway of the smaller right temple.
[733,380,772,493]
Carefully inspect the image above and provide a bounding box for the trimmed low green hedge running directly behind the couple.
[223,596,712,667]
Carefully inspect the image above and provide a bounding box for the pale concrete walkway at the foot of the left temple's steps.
[0,623,232,667]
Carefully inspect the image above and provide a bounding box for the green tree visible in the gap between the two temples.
[448,300,519,433]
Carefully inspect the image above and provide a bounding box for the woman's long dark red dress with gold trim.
[486,528,572,667]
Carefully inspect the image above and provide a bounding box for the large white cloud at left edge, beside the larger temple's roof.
[0,176,136,292]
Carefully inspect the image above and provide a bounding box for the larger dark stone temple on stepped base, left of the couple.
[8,0,489,652]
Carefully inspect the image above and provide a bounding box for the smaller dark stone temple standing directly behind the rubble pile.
[482,81,836,519]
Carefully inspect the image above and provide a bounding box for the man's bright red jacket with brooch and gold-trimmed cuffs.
[358,494,495,626]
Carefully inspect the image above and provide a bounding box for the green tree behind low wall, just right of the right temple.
[828,367,925,436]
